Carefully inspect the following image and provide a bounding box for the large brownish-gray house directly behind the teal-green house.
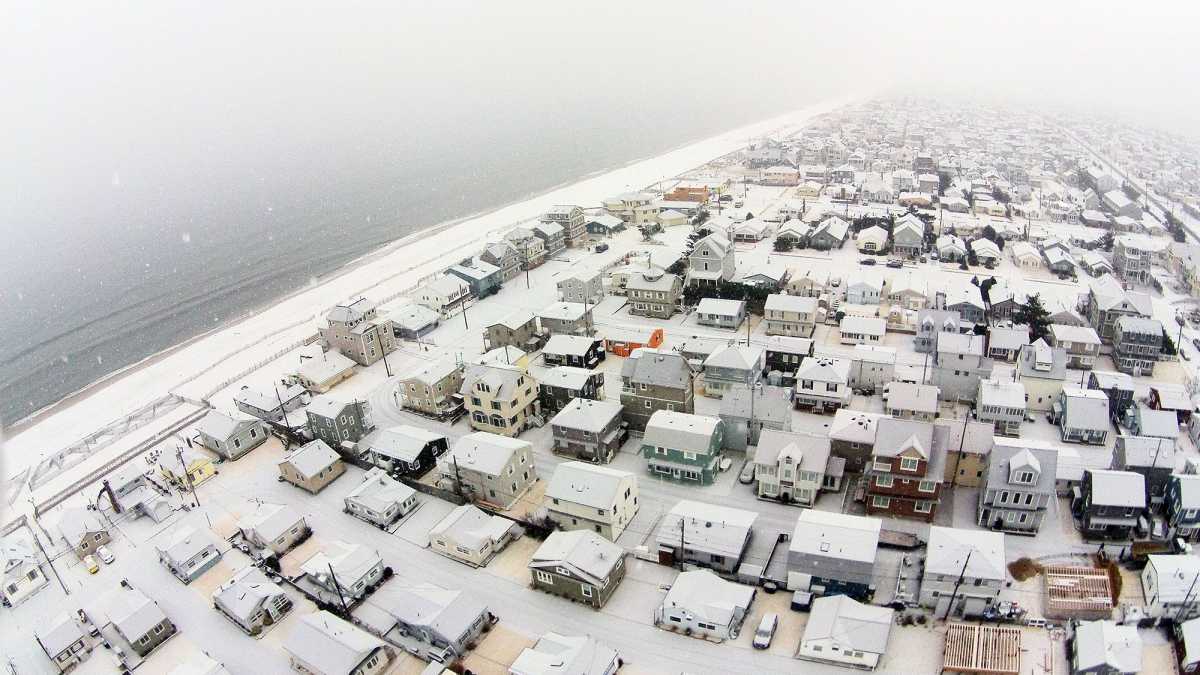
[620,348,695,431]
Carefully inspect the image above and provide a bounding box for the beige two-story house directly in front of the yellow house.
[438,431,538,509]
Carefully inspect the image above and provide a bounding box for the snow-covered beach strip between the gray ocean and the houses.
[0,101,844,478]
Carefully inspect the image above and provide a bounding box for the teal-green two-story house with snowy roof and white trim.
[641,410,725,485]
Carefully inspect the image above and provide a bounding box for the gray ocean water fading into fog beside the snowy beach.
[0,96,803,424]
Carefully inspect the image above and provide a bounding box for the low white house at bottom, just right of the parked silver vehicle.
[796,596,895,670]
